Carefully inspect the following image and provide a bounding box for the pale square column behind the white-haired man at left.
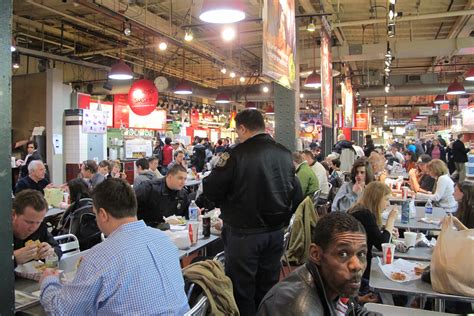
[46,68,72,184]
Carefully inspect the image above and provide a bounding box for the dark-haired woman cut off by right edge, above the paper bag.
[454,181,474,229]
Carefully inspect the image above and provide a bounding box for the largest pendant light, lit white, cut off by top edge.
[199,0,245,24]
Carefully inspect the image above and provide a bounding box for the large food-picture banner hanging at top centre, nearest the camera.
[262,0,296,89]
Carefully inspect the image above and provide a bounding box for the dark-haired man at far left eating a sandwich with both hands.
[12,189,62,265]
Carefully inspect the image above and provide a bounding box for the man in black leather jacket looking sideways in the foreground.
[258,212,378,316]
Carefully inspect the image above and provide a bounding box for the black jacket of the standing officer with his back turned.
[203,134,303,229]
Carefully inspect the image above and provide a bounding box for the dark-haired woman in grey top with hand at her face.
[331,158,374,212]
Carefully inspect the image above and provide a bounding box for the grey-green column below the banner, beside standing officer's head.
[273,83,300,151]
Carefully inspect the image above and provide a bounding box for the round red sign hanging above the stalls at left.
[128,79,158,116]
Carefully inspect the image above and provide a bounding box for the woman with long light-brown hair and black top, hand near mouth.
[347,181,398,294]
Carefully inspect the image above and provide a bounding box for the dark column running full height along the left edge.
[0,0,15,315]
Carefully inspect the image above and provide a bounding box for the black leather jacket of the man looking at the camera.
[257,263,380,316]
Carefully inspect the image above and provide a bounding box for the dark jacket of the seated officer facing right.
[134,177,189,226]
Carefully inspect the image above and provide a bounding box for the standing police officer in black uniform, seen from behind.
[203,110,302,316]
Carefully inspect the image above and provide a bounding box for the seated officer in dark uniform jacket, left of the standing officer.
[134,165,189,227]
